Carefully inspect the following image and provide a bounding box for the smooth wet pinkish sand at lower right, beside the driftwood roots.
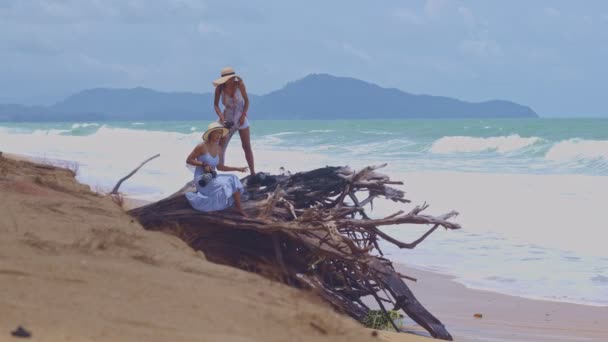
[394,263,608,342]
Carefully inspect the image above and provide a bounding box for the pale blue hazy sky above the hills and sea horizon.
[0,0,608,117]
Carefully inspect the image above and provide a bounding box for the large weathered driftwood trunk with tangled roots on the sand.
[130,164,460,340]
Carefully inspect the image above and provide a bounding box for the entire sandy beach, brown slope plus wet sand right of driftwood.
[0,154,608,341]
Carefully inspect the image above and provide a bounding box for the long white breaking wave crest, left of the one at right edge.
[430,134,542,154]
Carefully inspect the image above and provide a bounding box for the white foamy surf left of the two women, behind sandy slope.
[2,125,200,195]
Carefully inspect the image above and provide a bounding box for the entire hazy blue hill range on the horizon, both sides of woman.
[0,74,538,121]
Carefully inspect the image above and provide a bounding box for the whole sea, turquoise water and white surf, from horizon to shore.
[0,119,608,306]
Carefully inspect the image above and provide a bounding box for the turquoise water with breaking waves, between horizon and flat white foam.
[0,119,608,175]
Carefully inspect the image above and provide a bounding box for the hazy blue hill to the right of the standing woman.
[252,74,538,119]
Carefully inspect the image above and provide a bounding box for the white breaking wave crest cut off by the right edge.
[545,139,608,162]
